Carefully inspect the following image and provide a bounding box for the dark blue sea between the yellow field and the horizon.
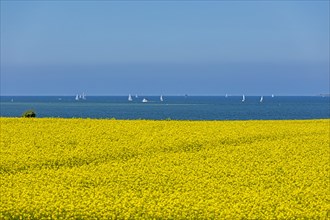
[0,96,330,120]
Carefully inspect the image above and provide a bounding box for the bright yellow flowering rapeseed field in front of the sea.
[0,118,330,219]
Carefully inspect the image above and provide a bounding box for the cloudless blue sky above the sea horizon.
[0,0,329,95]
